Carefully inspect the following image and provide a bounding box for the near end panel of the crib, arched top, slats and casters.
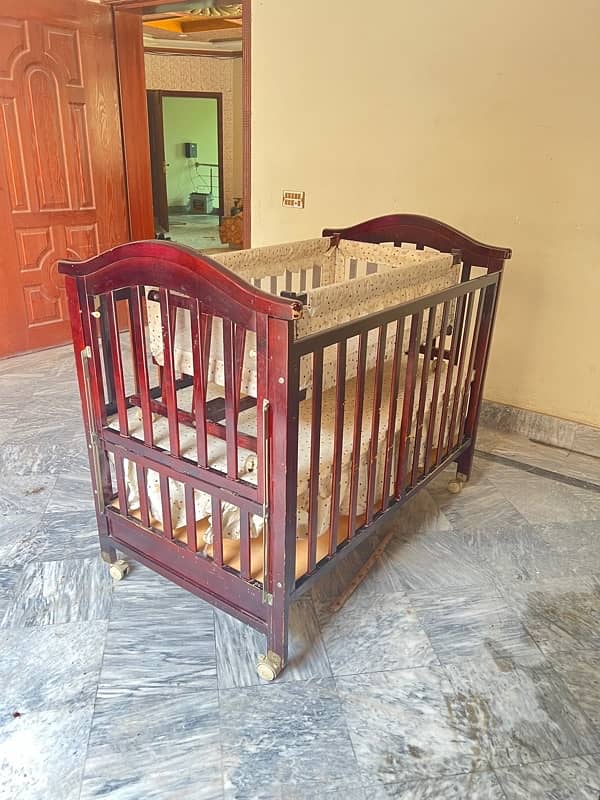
[59,242,301,673]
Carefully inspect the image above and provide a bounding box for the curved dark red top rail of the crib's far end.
[323,214,512,268]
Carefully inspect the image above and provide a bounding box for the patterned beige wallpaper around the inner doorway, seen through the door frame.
[145,53,239,214]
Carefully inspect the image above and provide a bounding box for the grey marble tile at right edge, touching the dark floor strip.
[488,464,600,524]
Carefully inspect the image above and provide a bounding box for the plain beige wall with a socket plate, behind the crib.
[252,0,600,425]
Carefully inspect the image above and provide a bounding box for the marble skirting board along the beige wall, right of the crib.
[481,400,600,457]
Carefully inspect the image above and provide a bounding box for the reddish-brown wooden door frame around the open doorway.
[110,0,252,247]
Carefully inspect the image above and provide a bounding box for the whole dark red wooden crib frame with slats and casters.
[59,214,511,679]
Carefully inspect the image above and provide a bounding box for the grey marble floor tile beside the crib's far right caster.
[429,460,525,532]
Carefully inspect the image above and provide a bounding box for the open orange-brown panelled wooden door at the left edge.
[0,0,129,356]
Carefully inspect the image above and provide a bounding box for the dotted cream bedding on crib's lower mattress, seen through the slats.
[110,357,454,544]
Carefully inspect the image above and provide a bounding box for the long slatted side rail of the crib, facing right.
[292,272,500,589]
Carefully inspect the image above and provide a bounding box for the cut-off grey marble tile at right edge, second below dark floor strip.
[534,520,600,575]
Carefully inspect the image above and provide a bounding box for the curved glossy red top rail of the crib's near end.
[58,239,302,320]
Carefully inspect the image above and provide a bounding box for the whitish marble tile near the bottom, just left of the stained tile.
[336,667,487,786]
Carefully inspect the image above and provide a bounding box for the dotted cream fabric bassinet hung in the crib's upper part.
[148,239,460,397]
